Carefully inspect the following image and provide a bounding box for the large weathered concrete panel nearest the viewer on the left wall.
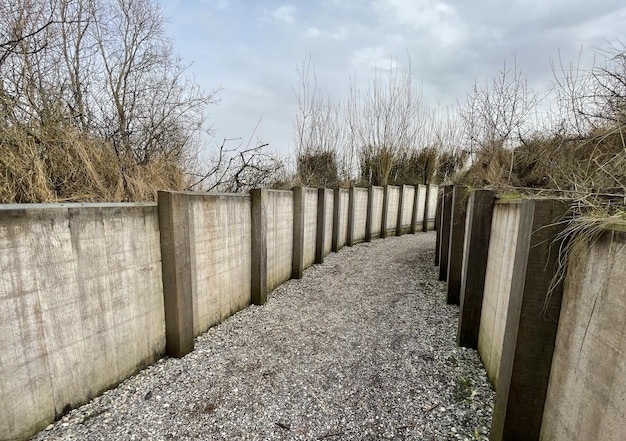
[0,204,165,440]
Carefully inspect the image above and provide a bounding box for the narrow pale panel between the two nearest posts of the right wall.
[478,201,521,385]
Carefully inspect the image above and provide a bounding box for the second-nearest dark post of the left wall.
[250,188,268,305]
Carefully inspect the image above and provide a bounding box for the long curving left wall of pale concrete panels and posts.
[0,183,438,440]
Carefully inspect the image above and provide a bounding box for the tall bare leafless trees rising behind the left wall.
[0,0,224,201]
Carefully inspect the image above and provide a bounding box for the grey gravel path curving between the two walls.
[33,233,494,441]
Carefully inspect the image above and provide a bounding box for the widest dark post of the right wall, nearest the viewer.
[490,199,569,441]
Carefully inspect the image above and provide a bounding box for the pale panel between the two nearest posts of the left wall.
[189,194,251,335]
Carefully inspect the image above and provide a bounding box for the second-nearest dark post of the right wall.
[457,190,496,349]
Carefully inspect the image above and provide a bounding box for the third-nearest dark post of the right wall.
[447,185,467,305]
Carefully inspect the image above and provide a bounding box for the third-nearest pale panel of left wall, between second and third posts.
[266,190,293,291]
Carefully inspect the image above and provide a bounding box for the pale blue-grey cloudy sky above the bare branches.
[160,0,626,154]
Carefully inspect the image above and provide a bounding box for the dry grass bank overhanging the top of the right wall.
[459,121,626,211]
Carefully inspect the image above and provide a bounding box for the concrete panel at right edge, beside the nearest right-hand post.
[540,229,626,441]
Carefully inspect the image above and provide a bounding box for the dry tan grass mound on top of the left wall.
[0,121,185,203]
